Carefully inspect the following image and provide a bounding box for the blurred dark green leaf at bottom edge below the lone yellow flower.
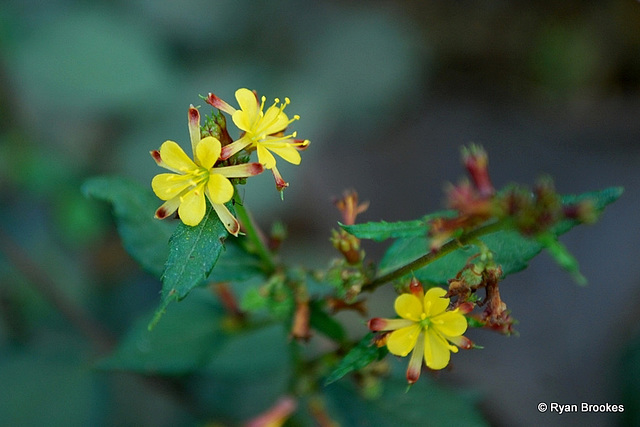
[324,358,488,427]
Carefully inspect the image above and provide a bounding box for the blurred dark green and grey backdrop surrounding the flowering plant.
[0,0,640,426]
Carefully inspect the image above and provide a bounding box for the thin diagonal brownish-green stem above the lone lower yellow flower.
[362,221,506,291]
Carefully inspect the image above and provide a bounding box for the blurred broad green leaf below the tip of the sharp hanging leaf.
[97,289,228,375]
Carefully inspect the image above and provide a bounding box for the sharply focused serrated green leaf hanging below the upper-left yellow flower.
[149,203,232,329]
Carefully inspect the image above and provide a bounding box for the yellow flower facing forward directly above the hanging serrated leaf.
[151,106,264,236]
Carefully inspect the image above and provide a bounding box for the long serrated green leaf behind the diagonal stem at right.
[379,187,622,285]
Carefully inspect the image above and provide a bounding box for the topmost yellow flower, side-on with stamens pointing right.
[202,88,309,189]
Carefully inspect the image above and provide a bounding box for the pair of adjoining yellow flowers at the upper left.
[151,89,309,232]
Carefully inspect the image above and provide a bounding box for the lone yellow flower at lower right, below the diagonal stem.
[369,280,472,383]
